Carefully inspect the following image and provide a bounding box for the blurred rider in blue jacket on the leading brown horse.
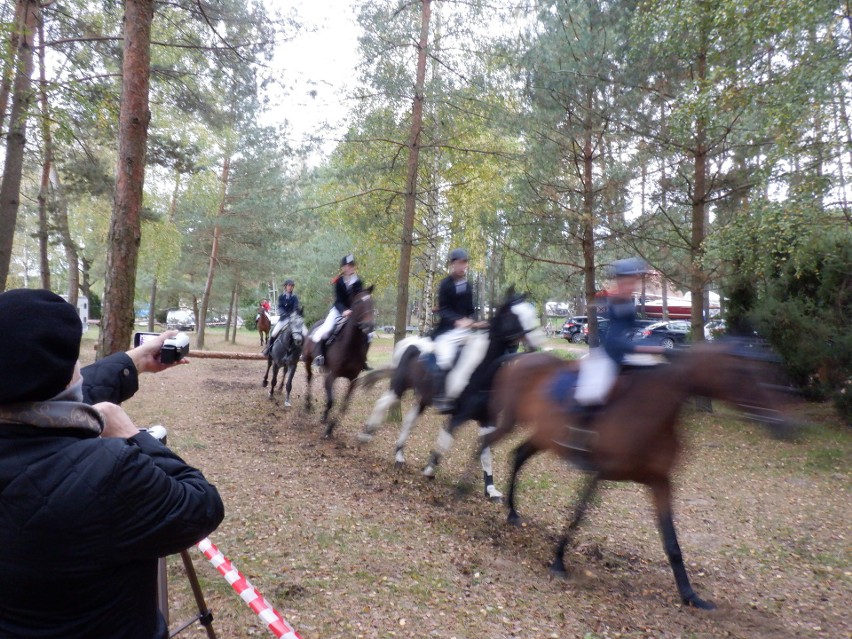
[574,257,666,423]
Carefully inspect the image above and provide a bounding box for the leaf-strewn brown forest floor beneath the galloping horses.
[78,329,852,639]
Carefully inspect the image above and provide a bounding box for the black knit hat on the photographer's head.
[0,288,83,404]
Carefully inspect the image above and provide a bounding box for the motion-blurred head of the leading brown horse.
[676,340,797,439]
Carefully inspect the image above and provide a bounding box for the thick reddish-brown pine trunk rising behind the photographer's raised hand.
[98,0,154,357]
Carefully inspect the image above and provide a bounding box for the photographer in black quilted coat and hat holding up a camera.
[0,289,224,639]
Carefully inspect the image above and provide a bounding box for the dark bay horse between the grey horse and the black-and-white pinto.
[302,286,376,437]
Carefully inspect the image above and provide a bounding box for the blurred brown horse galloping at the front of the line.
[481,343,792,609]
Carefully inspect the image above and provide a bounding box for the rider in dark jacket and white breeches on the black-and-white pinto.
[432,248,475,413]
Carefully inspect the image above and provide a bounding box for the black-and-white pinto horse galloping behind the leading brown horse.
[359,289,543,501]
